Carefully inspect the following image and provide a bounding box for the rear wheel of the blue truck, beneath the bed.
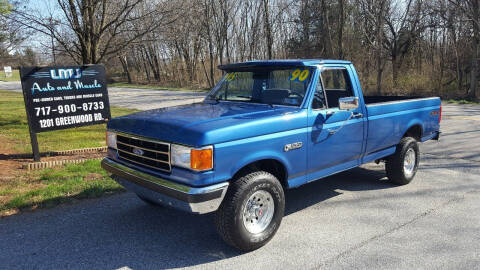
[385,137,420,185]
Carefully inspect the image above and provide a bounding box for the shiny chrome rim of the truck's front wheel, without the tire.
[243,190,275,234]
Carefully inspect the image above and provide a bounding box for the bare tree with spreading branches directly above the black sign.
[12,0,173,64]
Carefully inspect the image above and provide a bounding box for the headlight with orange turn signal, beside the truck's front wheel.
[171,144,213,171]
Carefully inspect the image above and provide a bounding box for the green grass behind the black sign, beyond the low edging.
[0,90,137,153]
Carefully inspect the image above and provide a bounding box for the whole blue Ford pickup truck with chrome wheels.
[102,60,441,251]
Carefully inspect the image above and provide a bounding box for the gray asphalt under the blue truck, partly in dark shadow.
[0,81,480,269]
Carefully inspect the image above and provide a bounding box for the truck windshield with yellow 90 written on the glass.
[207,67,313,106]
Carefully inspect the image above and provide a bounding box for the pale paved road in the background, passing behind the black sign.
[0,81,206,110]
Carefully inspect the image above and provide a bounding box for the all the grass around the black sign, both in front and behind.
[0,90,139,216]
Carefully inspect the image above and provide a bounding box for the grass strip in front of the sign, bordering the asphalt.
[0,160,124,215]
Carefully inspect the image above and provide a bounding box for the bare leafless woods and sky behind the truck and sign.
[0,0,480,99]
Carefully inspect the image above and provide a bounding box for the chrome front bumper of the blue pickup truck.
[102,158,228,214]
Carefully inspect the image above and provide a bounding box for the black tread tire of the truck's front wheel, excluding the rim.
[215,171,285,251]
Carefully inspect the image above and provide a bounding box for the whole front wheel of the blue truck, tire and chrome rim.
[215,171,285,251]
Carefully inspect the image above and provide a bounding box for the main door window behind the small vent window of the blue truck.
[320,68,354,108]
